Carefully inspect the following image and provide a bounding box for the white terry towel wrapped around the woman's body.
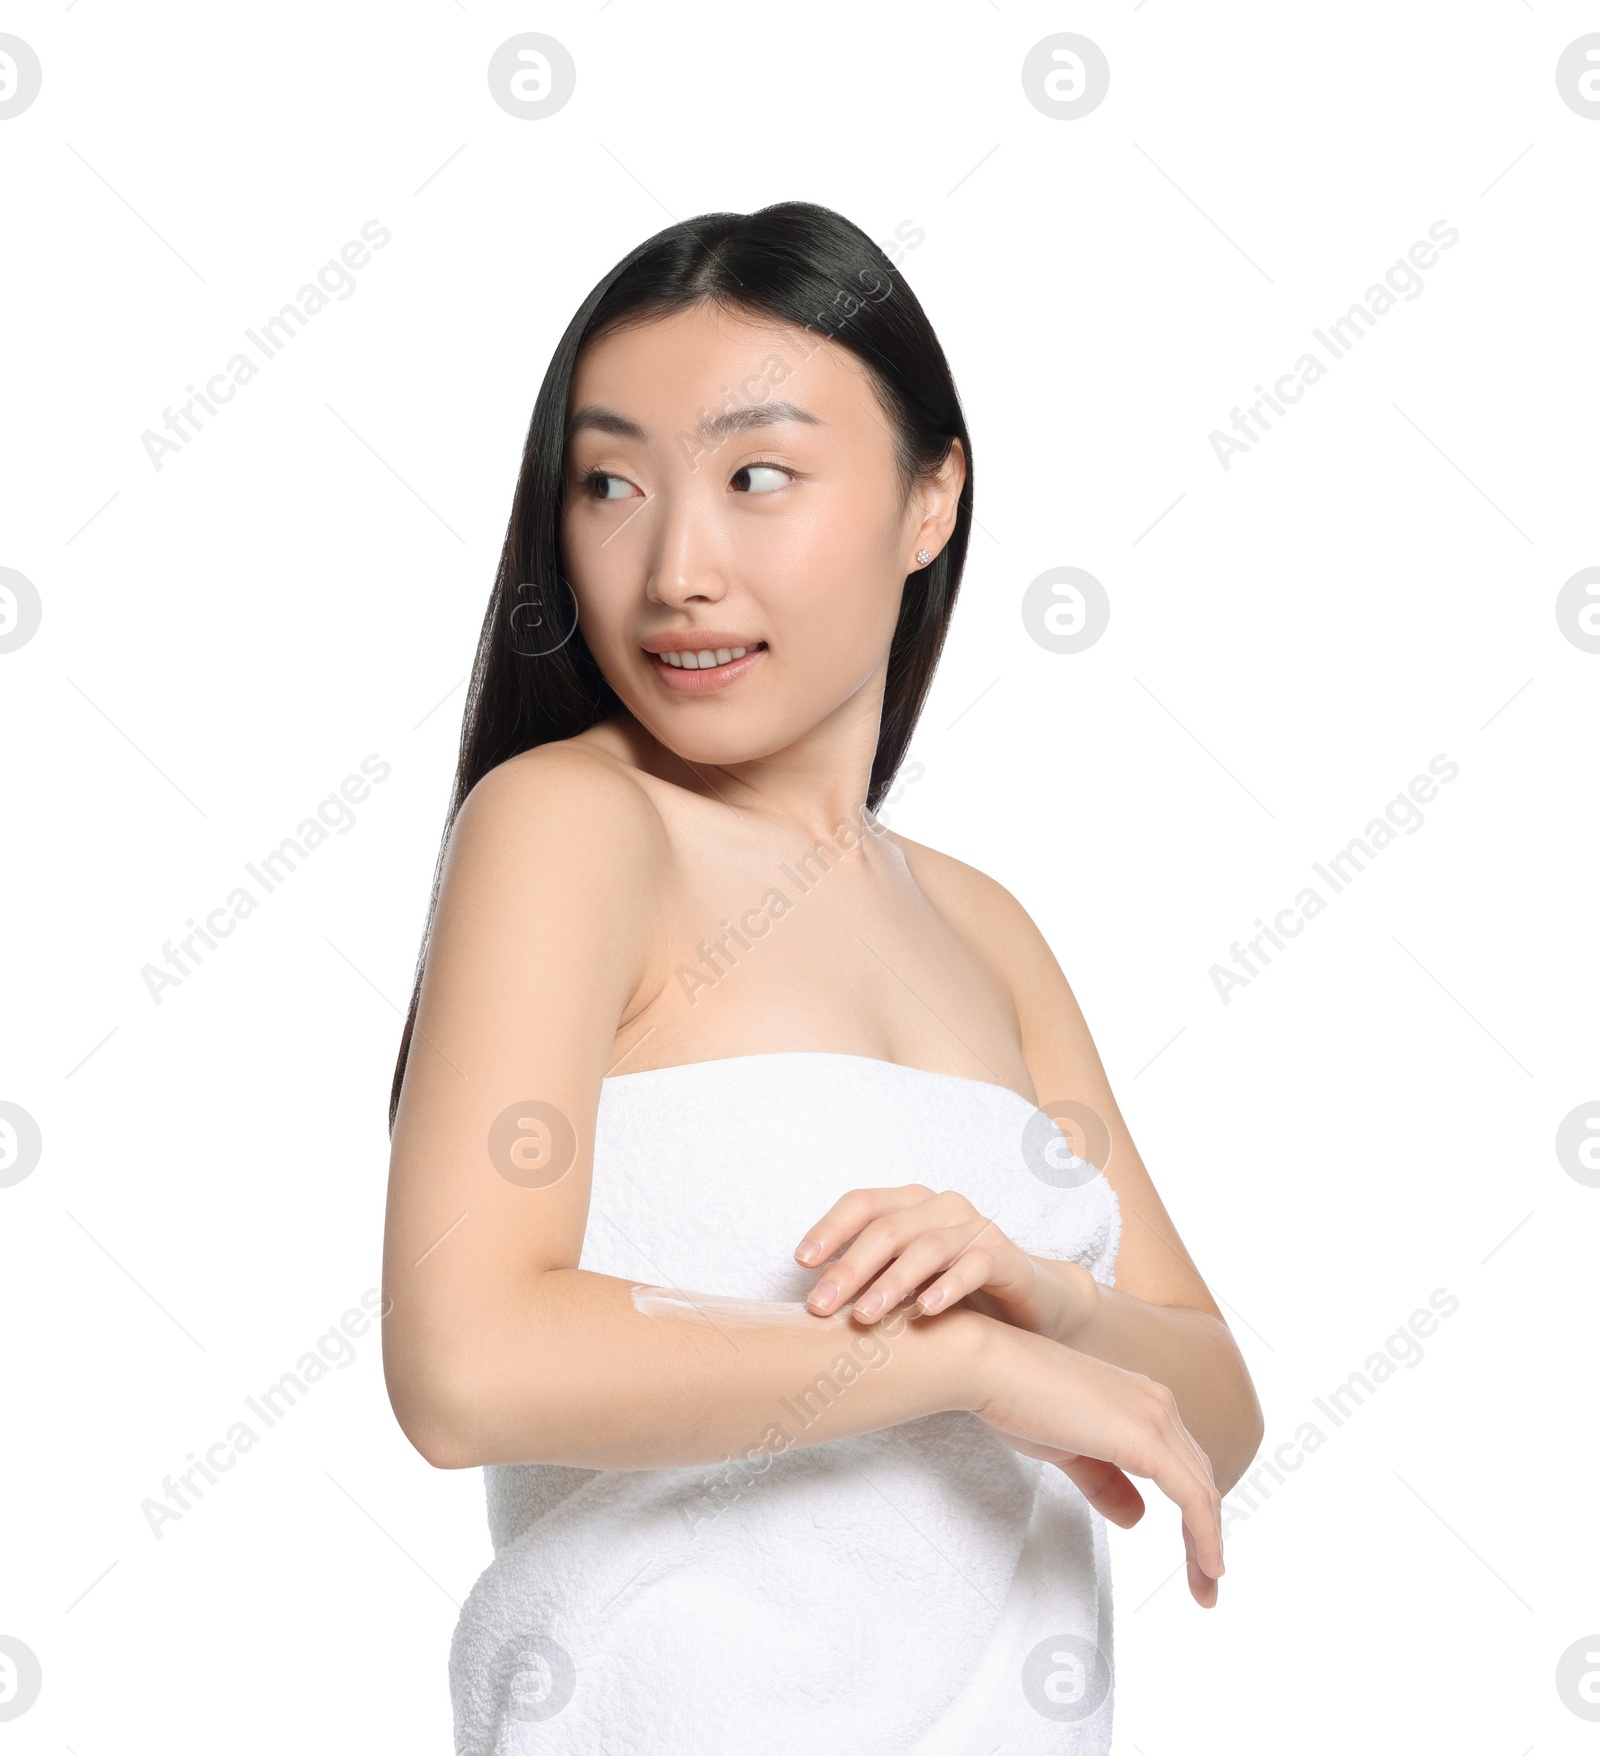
[450,1050,1121,1756]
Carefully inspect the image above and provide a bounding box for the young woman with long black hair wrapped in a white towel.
[385,202,1263,1756]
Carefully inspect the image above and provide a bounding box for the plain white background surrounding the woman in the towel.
[0,0,1600,1756]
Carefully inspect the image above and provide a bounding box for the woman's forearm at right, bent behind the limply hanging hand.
[1034,1257,1265,1494]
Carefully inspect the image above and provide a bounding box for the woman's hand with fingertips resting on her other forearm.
[794,1184,1096,1342]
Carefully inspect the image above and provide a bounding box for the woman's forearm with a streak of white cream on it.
[385,1268,992,1470]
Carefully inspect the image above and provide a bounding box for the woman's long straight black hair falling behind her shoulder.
[388,202,973,1133]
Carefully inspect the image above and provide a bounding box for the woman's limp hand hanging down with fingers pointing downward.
[971,1328,1222,1610]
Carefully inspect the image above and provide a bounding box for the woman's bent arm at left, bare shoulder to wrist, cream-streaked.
[383,746,999,1470]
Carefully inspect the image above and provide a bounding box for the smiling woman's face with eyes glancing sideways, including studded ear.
[562,304,962,764]
